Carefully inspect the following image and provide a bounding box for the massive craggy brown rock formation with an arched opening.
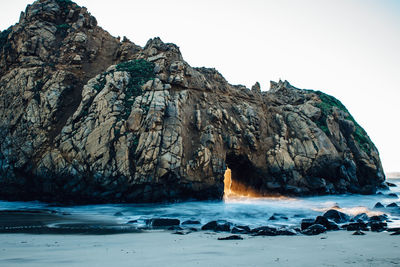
[0,0,385,202]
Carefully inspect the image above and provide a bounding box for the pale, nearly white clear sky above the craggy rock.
[0,0,400,172]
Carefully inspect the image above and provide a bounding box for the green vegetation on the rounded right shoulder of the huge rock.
[315,91,374,153]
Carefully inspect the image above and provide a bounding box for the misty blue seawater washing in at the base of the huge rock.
[0,179,400,227]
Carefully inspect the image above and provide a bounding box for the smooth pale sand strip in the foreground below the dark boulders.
[0,231,400,266]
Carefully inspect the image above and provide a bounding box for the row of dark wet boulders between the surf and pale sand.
[126,209,400,240]
